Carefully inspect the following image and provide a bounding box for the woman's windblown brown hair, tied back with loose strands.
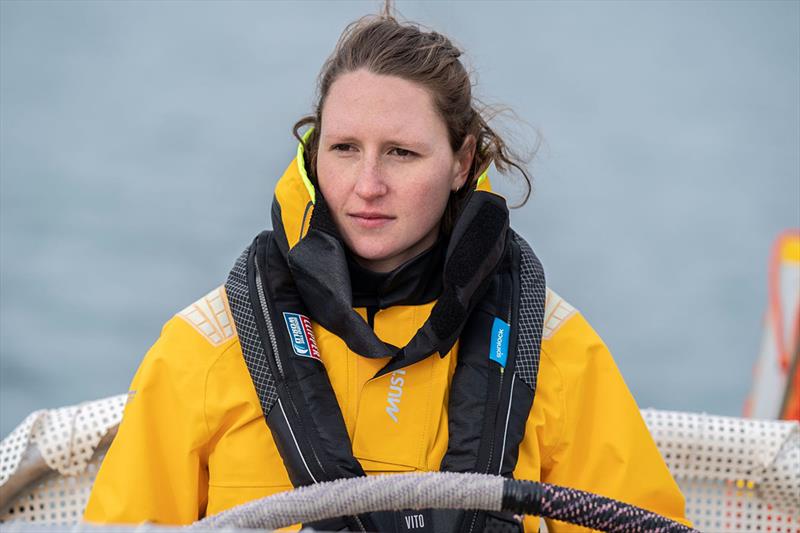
[293,1,531,234]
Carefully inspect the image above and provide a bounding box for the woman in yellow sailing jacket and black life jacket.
[85,9,684,531]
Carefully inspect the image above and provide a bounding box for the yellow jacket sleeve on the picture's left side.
[84,317,217,524]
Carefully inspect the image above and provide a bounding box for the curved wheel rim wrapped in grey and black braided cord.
[188,472,695,533]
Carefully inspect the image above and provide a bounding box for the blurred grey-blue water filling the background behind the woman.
[0,0,800,435]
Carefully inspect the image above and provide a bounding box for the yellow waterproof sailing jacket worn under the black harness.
[85,156,688,533]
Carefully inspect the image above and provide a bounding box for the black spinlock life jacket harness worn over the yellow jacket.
[225,191,545,533]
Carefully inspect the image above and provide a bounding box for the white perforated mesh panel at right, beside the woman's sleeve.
[642,409,800,533]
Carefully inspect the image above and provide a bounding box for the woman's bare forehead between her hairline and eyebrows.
[322,70,447,140]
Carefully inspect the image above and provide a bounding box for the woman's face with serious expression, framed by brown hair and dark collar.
[317,70,474,272]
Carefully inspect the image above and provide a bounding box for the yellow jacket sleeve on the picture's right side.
[539,313,689,533]
